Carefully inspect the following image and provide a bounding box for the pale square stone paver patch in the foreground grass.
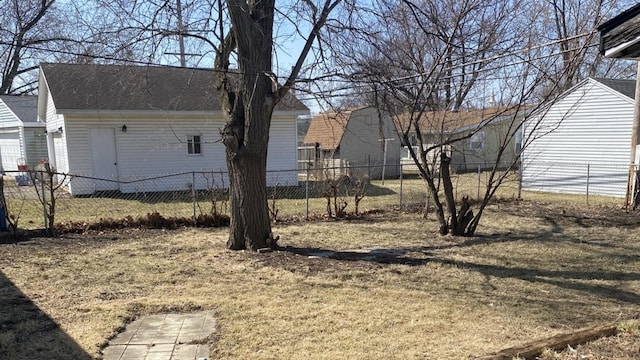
[102,311,216,360]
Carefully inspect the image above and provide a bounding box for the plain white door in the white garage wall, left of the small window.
[89,128,119,191]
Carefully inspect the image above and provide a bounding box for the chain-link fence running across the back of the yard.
[0,164,628,233]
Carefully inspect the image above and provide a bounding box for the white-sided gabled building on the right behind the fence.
[522,78,635,197]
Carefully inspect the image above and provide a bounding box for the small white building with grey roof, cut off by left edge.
[0,95,47,172]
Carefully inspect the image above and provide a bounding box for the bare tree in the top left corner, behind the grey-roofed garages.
[0,0,159,94]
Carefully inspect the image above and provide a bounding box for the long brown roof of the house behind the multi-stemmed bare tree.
[393,107,518,133]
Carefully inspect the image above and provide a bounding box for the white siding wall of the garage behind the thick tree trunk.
[56,113,298,195]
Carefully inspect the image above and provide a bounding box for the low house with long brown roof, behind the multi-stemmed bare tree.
[395,106,524,172]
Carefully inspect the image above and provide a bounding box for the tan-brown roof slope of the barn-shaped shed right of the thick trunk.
[304,108,362,150]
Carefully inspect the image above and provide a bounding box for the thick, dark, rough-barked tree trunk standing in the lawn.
[215,0,277,250]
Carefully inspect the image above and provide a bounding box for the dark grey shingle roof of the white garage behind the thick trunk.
[40,63,309,111]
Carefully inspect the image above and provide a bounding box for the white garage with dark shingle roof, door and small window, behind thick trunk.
[38,64,309,195]
